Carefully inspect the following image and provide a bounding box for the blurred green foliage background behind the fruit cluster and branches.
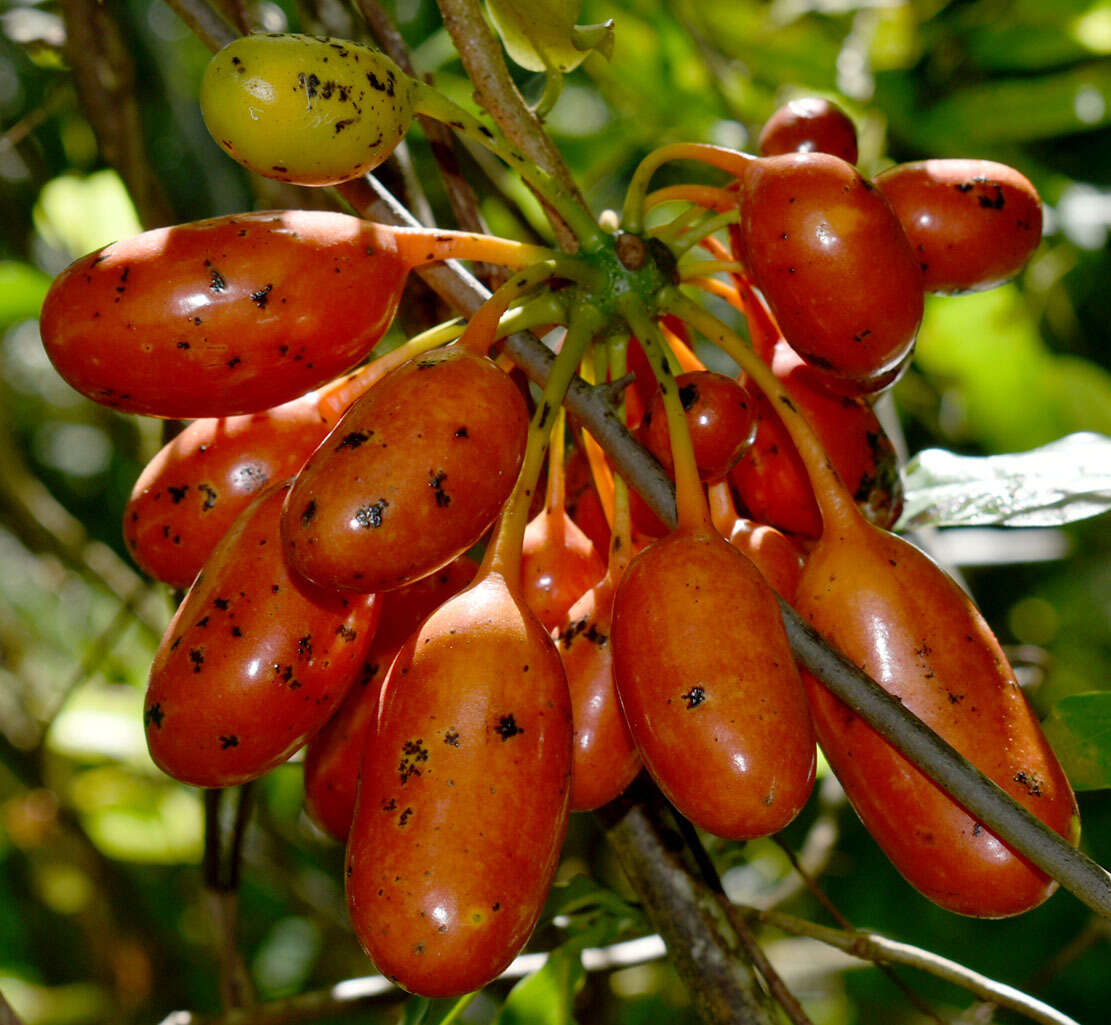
[0,0,1111,1025]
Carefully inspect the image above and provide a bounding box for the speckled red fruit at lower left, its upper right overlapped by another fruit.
[143,483,380,786]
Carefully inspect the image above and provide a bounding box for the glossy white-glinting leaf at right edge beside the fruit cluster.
[897,433,1111,530]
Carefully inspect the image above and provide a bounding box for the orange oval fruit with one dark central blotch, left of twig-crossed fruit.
[611,530,815,840]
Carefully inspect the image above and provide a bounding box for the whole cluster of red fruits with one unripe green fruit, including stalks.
[41,36,1078,995]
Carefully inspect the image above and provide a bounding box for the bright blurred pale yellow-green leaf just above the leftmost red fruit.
[33,170,142,260]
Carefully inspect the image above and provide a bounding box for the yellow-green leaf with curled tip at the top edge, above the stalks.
[487,0,613,72]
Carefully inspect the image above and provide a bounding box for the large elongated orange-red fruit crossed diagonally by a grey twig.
[795,521,1079,917]
